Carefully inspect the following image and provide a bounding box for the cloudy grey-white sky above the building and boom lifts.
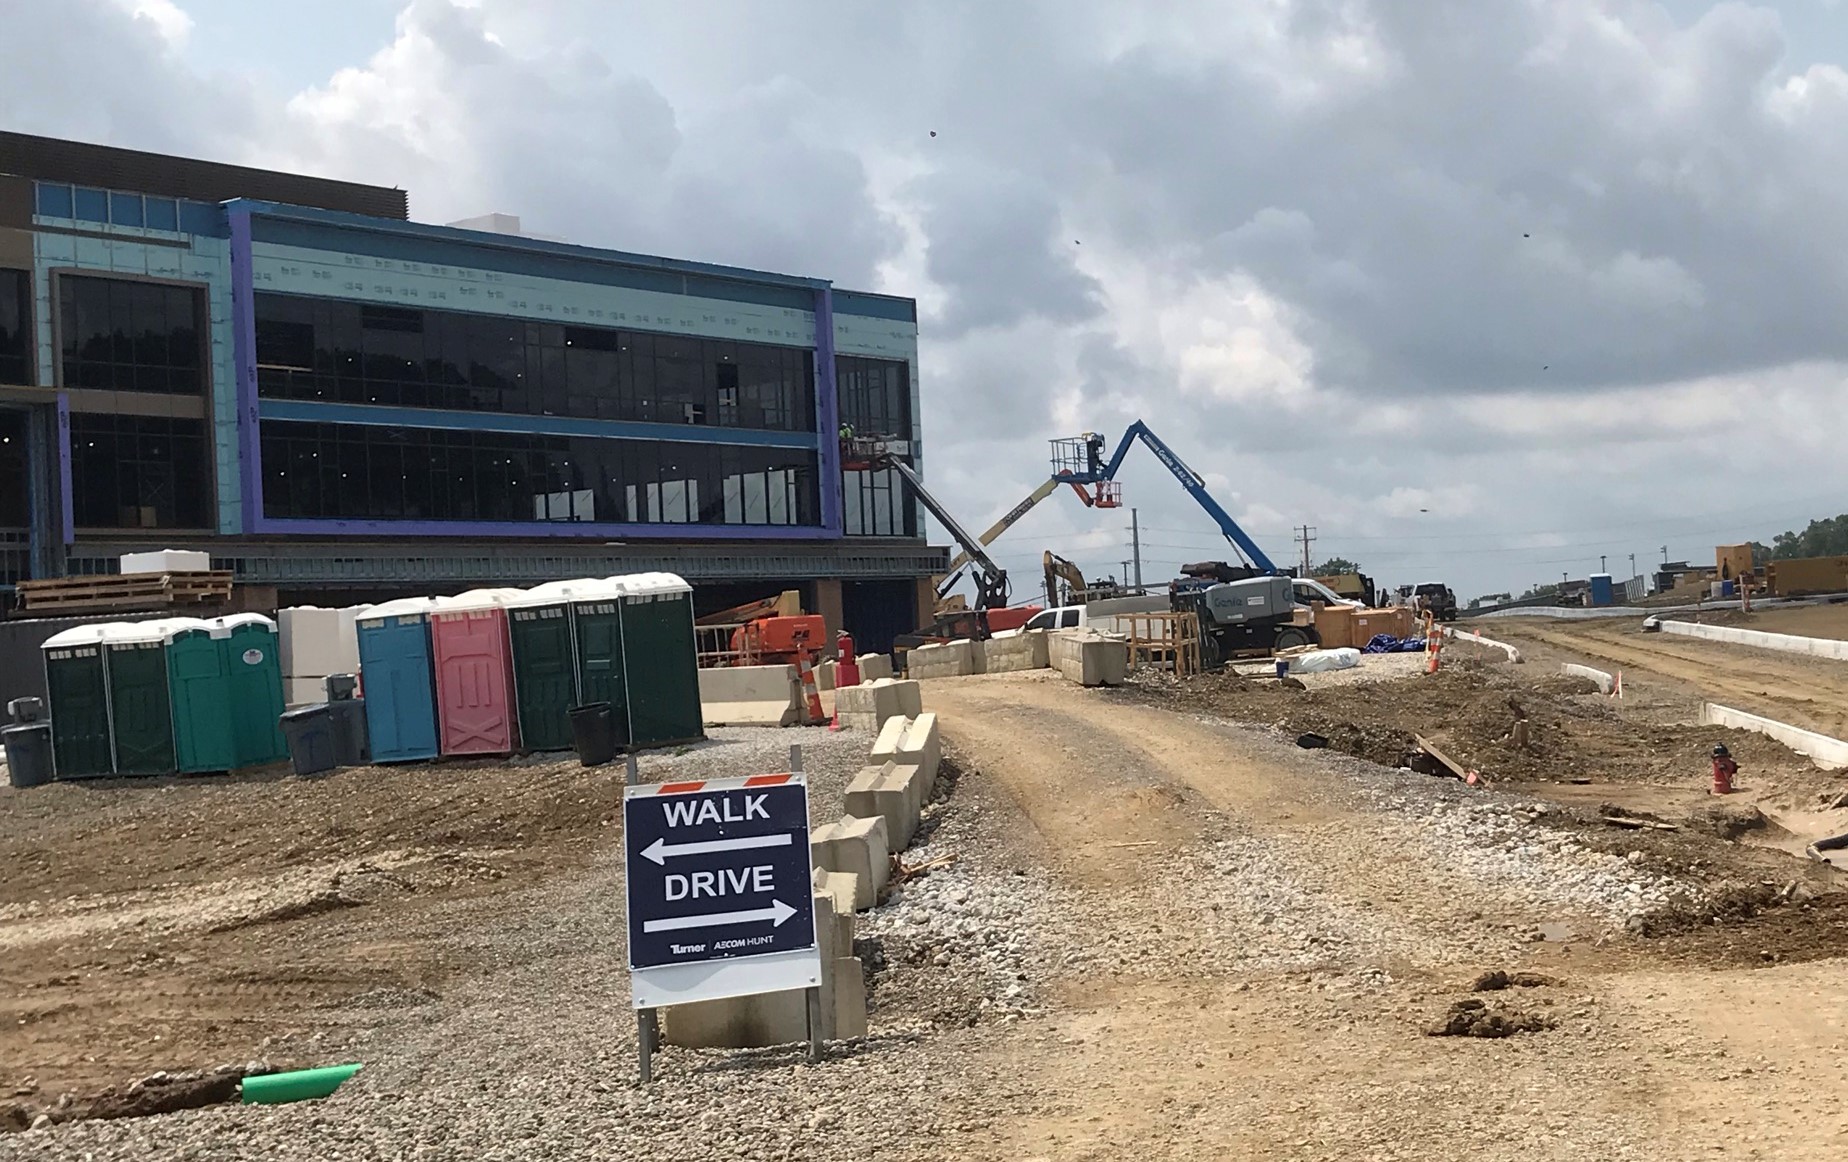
[0,0,1848,599]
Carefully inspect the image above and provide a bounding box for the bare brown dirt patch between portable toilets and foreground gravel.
[0,746,621,1097]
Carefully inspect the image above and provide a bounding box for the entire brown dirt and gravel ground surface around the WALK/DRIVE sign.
[0,653,1848,1162]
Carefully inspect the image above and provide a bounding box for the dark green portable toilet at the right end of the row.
[614,573,706,746]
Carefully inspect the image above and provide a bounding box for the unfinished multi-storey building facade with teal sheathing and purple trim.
[0,135,946,643]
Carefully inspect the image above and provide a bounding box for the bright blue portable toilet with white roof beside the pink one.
[355,597,436,763]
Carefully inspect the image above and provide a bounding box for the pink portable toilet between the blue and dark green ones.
[431,589,521,754]
